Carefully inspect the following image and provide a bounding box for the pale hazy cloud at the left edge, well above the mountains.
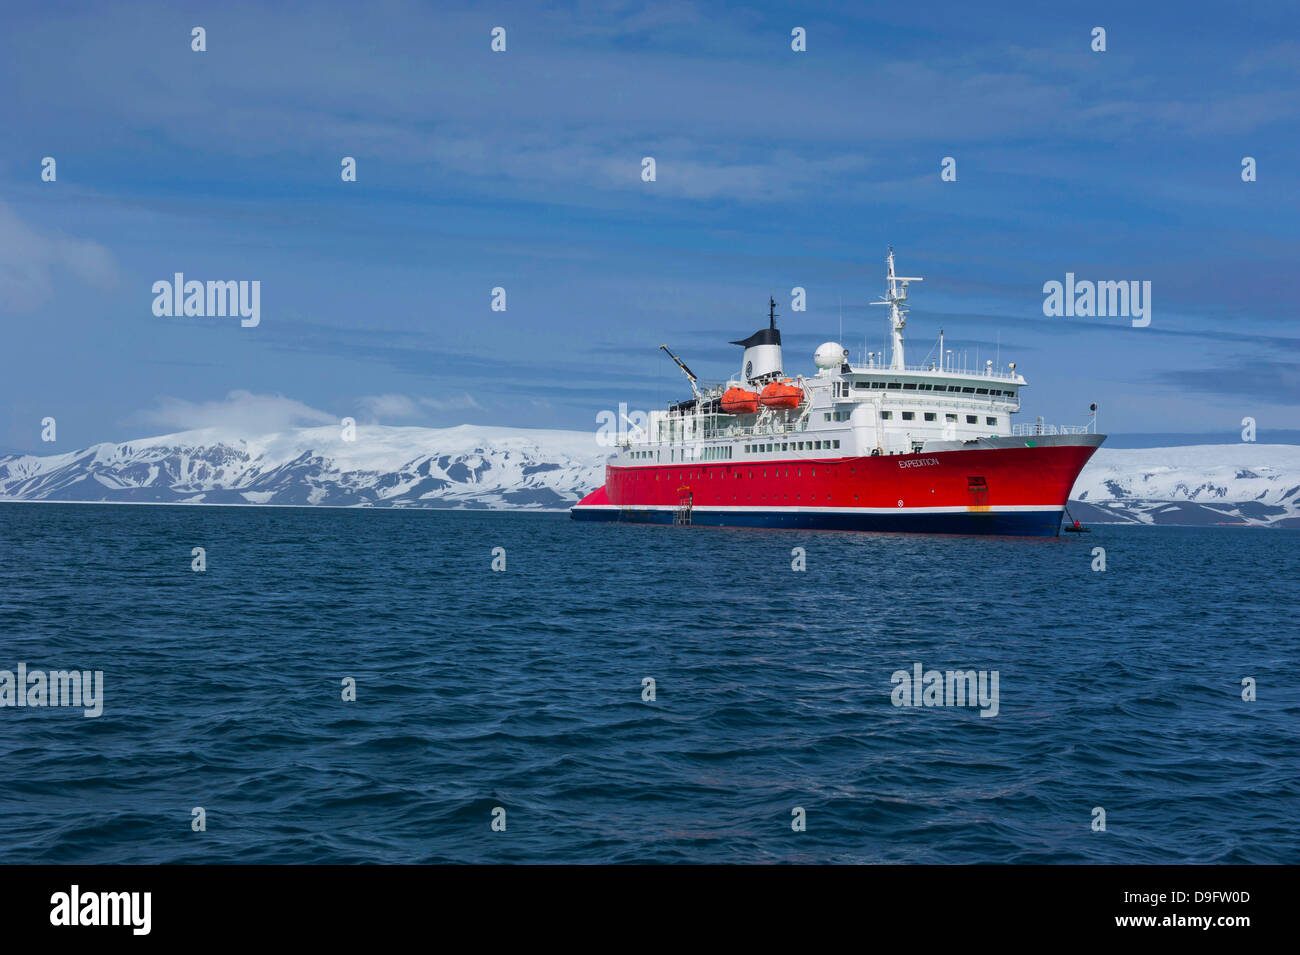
[0,203,117,312]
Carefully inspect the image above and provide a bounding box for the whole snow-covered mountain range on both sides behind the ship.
[0,425,1300,528]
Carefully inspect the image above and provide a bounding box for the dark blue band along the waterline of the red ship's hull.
[569,507,1062,537]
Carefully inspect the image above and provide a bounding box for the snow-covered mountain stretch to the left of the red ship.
[0,425,607,509]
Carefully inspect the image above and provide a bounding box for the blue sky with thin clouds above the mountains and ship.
[0,0,1300,453]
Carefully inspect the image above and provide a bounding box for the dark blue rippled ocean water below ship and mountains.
[0,504,1300,863]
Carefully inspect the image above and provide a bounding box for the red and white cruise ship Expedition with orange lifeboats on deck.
[571,248,1105,537]
